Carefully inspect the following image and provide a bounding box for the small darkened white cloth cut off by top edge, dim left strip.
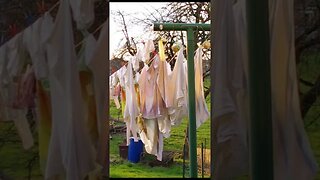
[69,0,97,30]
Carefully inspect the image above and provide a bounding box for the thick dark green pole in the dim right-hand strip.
[247,0,273,180]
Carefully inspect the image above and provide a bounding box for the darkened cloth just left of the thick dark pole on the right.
[211,0,249,179]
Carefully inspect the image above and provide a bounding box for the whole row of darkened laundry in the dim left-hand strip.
[0,0,108,179]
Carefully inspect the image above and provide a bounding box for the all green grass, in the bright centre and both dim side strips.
[0,62,320,180]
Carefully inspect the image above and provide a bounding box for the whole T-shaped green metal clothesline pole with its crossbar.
[153,23,210,178]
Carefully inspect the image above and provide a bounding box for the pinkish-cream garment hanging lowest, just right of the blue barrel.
[139,55,166,160]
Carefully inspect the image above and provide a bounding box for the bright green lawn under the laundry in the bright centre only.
[110,79,210,178]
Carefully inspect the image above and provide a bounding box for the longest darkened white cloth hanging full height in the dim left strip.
[45,0,95,179]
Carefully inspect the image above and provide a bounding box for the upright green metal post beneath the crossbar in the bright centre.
[187,27,198,178]
